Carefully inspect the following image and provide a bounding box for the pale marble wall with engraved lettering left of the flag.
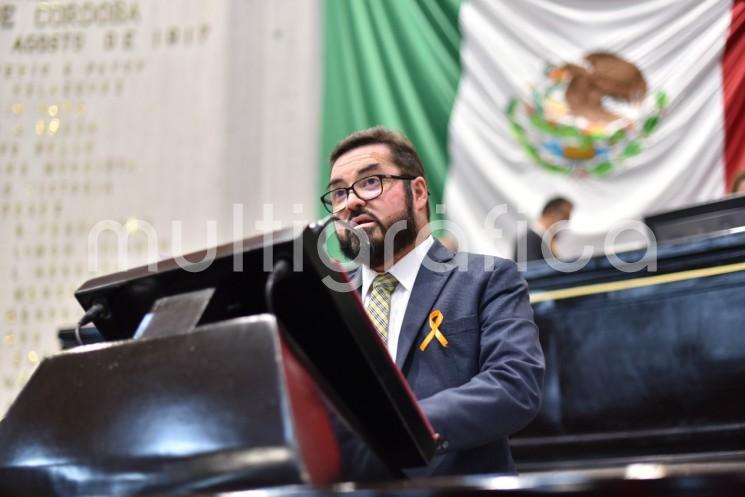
[0,0,321,416]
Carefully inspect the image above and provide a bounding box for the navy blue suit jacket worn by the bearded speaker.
[342,240,544,479]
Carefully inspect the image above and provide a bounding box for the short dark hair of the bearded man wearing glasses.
[329,126,427,180]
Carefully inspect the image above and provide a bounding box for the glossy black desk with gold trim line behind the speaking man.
[512,232,745,470]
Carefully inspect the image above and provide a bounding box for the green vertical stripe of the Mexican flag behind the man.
[319,0,461,224]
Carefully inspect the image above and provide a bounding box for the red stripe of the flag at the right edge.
[722,0,745,191]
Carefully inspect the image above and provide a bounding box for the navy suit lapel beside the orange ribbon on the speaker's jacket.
[396,239,456,369]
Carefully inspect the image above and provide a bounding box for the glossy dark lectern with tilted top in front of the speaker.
[0,225,435,496]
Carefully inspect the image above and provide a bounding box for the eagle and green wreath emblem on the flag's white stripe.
[507,52,668,176]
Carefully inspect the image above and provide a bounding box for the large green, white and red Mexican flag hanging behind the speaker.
[321,0,745,256]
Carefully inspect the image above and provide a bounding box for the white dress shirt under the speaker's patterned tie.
[361,235,435,361]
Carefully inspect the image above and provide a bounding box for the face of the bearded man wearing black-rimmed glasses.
[329,144,417,268]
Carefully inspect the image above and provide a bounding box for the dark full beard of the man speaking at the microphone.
[337,188,418,268]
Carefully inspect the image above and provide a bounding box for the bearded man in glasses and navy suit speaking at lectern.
[322,127,544,479]
